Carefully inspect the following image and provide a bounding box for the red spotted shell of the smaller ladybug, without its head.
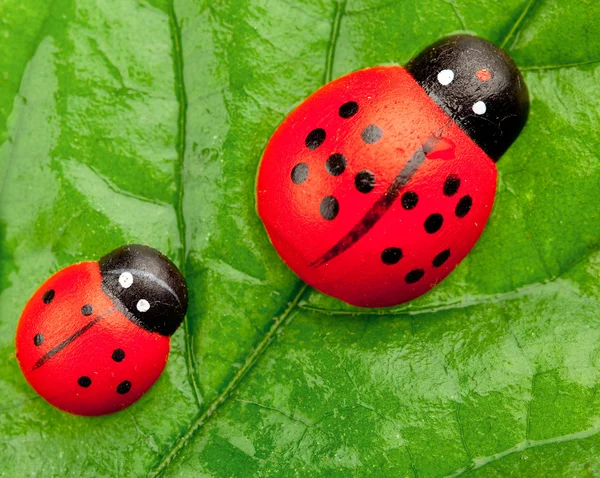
[16,262,169,415]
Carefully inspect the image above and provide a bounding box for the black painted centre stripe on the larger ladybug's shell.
[311,135,441,267]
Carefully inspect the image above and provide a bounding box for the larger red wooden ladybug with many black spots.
[257,35,529,307]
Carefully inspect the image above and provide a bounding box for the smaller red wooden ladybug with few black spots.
[16,245,187,415]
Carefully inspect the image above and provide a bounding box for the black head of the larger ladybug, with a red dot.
[406,35,529,161]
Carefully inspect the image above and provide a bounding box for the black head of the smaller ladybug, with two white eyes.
[99,244,187,336]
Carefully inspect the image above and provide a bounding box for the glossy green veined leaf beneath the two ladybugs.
[0,0,600,476]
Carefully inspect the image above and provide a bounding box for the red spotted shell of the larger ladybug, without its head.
[257,66,497,307]
